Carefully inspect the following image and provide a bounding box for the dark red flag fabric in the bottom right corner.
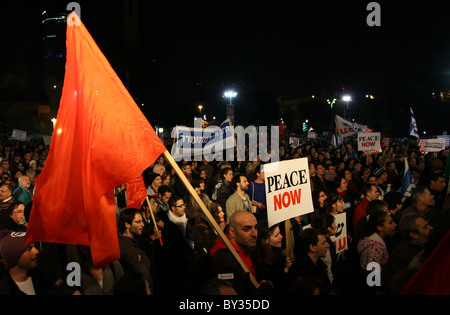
[401,231,450,295]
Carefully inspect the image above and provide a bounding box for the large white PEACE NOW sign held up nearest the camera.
[263,158,314,227]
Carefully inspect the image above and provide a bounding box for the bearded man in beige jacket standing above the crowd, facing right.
[225,175,252,222]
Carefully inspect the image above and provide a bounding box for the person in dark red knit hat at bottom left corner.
[0,230,43,295]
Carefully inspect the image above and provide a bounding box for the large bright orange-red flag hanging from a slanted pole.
[26,12,166,267]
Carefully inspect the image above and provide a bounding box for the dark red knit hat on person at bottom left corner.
[0,230,30,269]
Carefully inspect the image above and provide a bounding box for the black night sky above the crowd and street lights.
[0,0,450,135]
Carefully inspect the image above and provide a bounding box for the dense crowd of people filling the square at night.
[0,137,450,295]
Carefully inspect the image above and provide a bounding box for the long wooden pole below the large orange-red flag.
[164,150,259,288]
